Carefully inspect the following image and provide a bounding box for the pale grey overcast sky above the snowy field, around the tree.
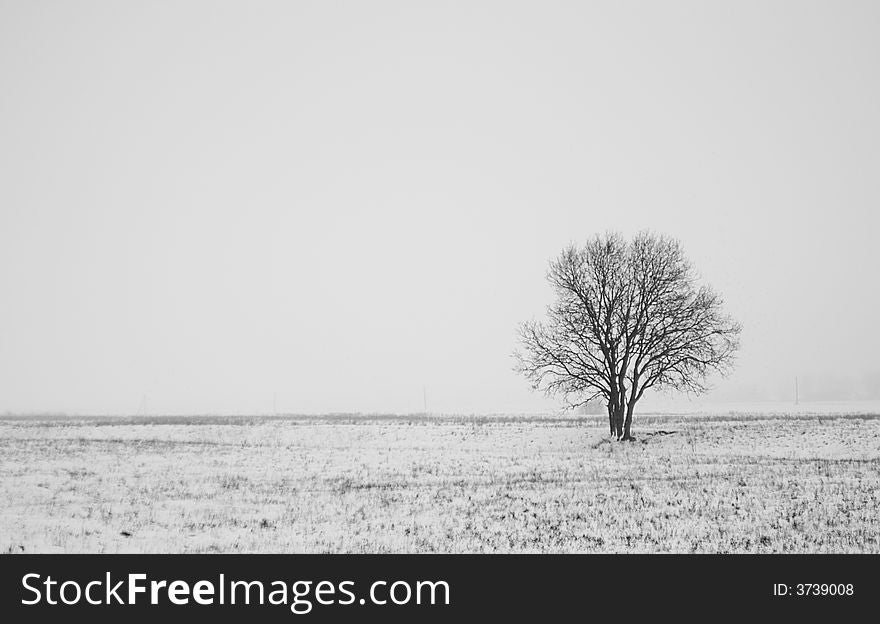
[0,0,880,413]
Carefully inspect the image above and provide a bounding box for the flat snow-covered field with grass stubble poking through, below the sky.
[0,410,880,553]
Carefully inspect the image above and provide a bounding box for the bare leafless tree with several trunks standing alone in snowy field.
[515,232,740,440]
